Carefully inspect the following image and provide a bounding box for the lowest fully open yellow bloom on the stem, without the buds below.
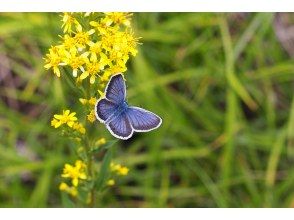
[61,160,87,187]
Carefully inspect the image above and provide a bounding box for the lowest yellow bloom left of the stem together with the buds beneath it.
[59,160,87,197]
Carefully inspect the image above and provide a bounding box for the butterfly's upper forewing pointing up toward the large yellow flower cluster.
[105,73,126,104]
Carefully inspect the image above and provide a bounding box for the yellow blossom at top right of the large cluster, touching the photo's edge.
[103,12,132,27]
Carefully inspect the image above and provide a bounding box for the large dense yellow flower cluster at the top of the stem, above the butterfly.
[44,12,138,84]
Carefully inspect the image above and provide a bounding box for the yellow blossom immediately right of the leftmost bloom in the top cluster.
[64,49,89,77]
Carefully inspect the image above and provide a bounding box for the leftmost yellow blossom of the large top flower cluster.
[44,46,64,77]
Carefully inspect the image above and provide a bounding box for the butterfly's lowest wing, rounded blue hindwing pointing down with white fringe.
[106,112,133,140]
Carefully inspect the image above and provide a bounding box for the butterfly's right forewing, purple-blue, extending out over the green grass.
[126,107,162,132]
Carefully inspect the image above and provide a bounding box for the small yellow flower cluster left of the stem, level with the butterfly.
[51,110,86,134]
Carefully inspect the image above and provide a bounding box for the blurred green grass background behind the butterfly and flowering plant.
[0,13,294,207]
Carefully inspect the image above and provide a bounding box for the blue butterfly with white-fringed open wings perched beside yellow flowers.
[95,73,162,140]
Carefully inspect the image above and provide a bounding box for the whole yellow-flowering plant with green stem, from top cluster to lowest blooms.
[44,12,138,206]
